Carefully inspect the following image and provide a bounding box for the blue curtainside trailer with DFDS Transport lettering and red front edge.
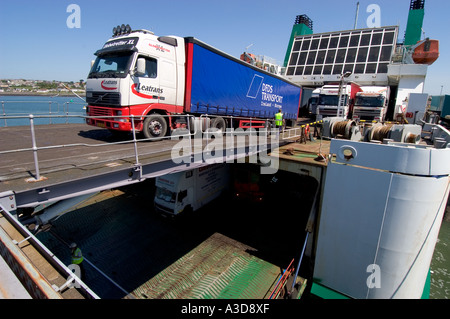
[185,38,301,120]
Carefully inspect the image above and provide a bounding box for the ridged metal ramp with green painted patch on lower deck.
[133,233,280,299]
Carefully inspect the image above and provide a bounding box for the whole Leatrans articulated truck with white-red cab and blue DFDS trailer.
[86,25,301,139]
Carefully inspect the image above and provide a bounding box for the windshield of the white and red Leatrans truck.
[88,52,133,79]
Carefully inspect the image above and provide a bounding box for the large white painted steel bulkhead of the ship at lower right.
[314,140,450,299]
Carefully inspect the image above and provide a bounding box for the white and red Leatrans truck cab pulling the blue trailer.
[86,27,185,131]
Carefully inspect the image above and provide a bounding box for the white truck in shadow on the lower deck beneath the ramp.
[154,164,229,216]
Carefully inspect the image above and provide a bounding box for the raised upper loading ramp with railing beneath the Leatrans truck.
[0,124,326,207]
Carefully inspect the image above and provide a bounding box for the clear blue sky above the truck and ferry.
[0,0,450,94]
